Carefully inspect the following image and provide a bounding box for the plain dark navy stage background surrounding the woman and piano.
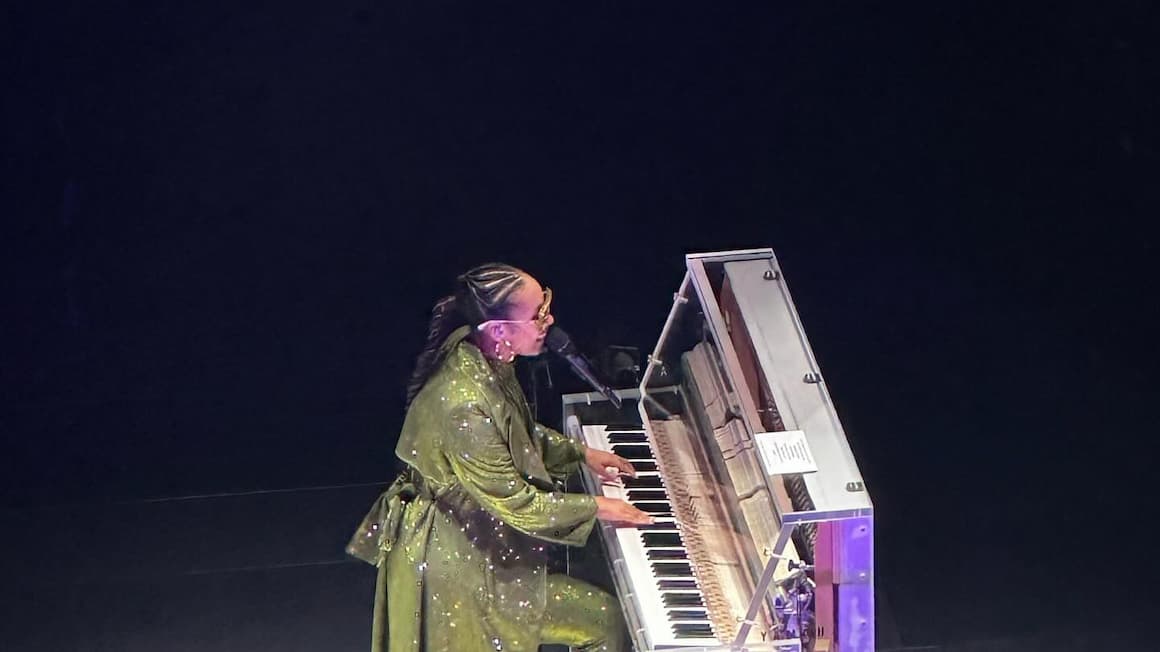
[0,0,1160,651]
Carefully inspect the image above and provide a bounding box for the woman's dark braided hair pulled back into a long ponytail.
[407,262,525,406]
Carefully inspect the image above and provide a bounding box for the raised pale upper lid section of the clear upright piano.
[640,248,872,522]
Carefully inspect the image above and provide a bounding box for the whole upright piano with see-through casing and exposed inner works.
[564,249,875,652]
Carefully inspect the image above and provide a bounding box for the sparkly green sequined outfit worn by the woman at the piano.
[348,327,628,652]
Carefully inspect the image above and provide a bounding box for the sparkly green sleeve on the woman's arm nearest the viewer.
[444,404,596,545]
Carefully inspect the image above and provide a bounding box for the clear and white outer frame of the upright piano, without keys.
[564,248,875,652]
